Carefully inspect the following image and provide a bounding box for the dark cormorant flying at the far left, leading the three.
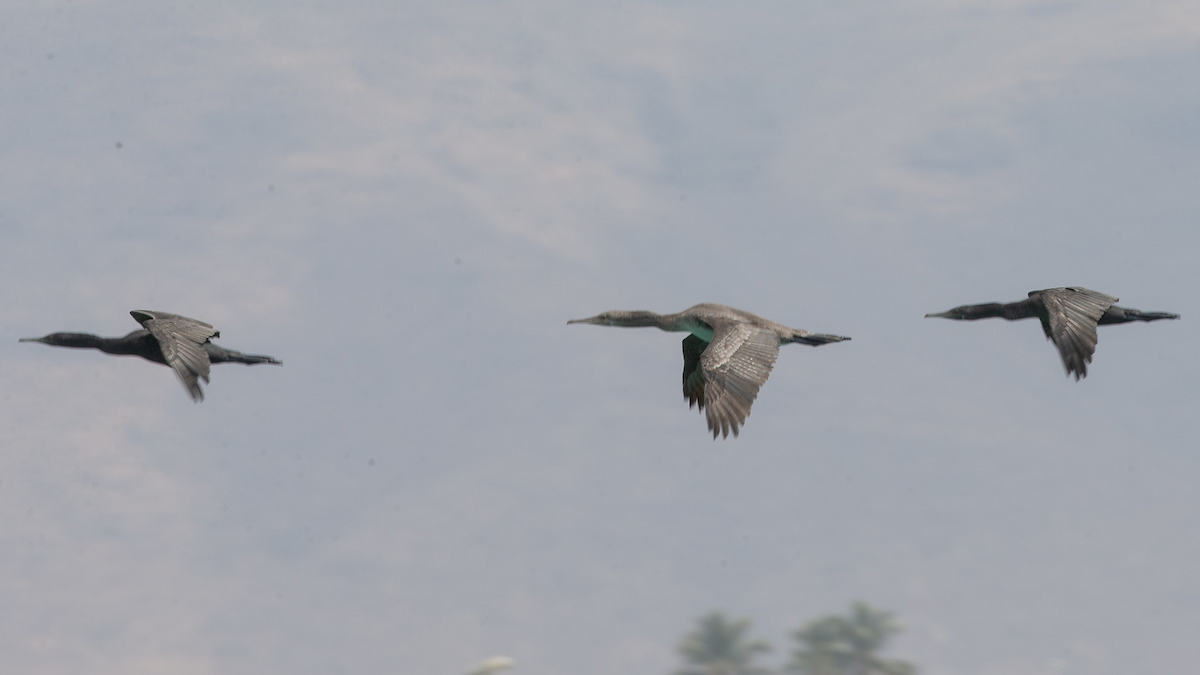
[19,310,283,402]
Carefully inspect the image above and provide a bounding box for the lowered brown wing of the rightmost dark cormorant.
[1042,288,1117,381]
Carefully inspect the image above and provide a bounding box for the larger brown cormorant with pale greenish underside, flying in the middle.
[566,303,850,438]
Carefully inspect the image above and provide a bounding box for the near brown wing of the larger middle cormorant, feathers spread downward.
[685,321,779,438]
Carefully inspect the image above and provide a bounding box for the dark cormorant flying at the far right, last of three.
[925,286,1180,382]
